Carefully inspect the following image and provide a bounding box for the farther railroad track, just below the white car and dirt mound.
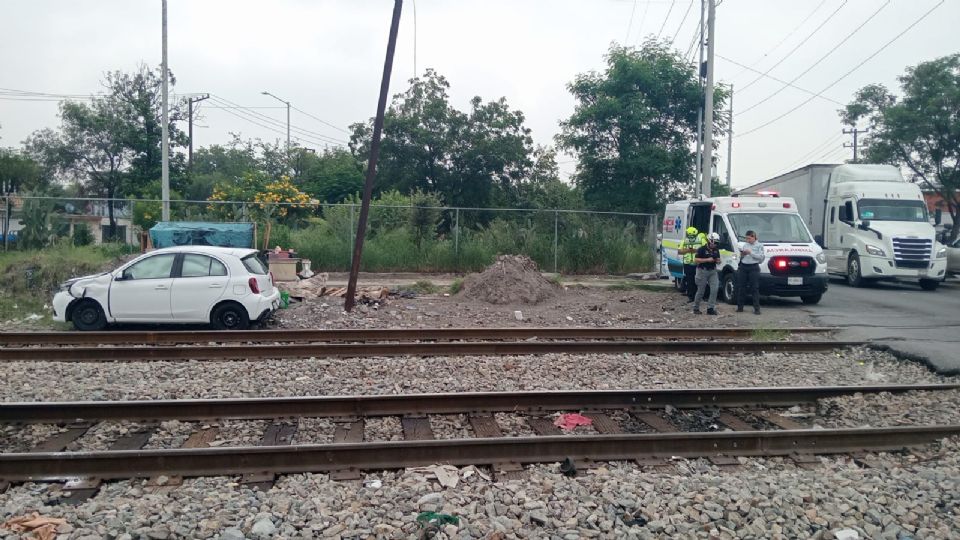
[0,328,848,362]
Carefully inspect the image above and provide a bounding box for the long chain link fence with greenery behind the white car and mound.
[0,196,657,274]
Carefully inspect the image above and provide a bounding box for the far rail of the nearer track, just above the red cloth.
[0,384,960,423]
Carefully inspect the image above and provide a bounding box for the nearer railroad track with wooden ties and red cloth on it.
[0,384,960,495]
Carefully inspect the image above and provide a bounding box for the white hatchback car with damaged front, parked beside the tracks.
[53,246,280,330]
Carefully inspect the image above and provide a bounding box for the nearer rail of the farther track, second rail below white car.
[0,341,862,362]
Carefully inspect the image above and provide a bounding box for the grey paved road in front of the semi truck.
[804,279,960,375]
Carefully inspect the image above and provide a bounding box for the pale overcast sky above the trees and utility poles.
[0,0,960,191]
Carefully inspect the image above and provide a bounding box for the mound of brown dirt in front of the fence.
[463,255,558,304]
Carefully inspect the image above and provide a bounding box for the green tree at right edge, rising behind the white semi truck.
[839,54,960,242]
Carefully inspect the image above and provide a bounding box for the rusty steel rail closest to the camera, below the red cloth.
[0,424,960,482]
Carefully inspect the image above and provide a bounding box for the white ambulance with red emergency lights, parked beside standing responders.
[660,192,827,304]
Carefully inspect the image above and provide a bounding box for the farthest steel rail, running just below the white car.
[0,327,834,345]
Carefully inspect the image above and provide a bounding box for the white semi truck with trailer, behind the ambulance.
[740,165,947,291]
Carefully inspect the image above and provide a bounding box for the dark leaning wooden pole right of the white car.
[343,0,403,312]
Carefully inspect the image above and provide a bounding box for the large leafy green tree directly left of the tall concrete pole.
[557,40,726,212]
